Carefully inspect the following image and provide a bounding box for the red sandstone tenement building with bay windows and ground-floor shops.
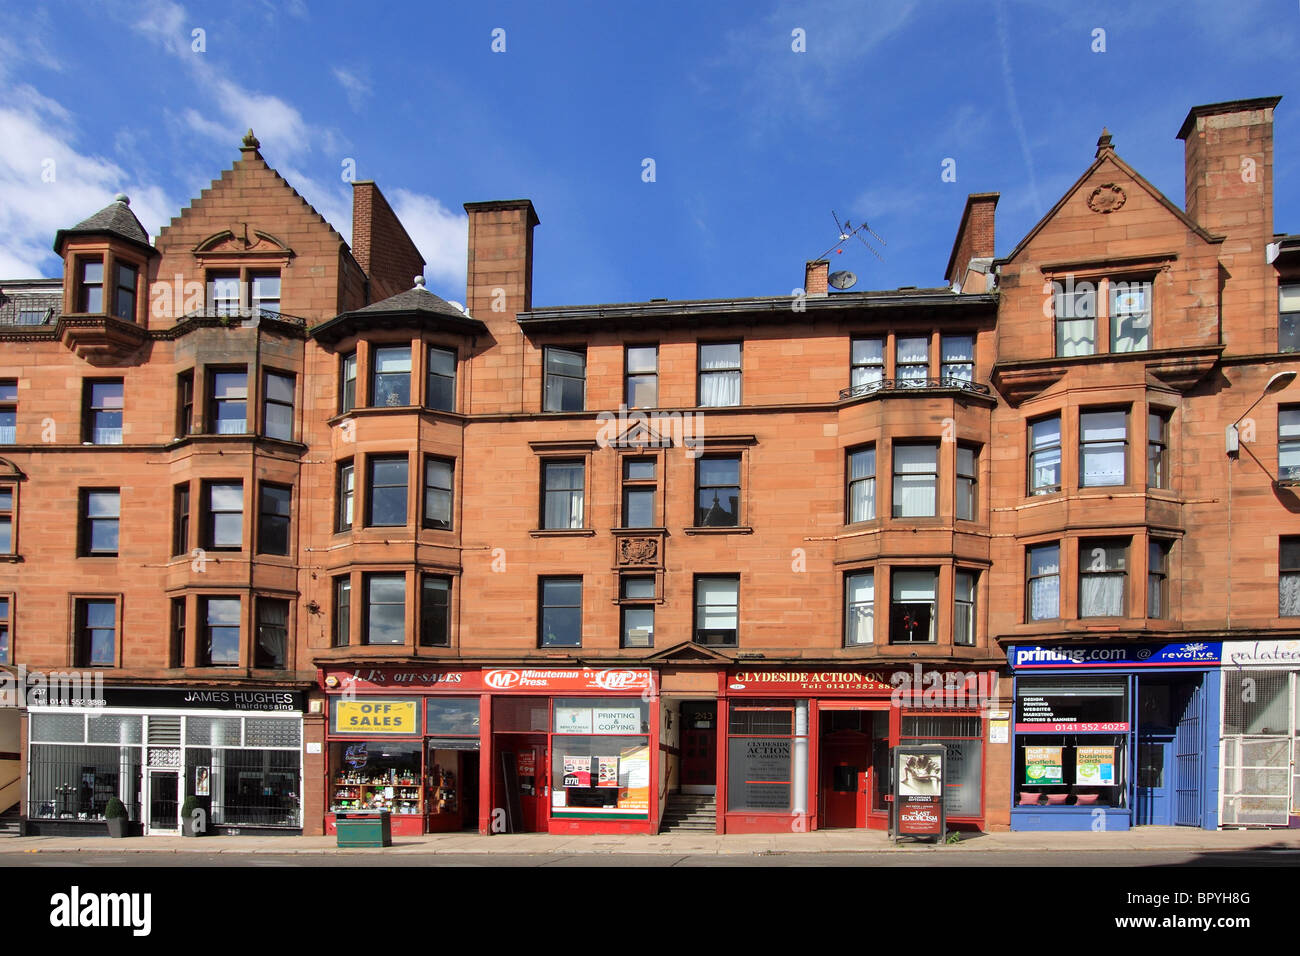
[0,99,1300,834]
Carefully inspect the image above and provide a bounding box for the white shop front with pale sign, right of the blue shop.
[1219,641,1300,827]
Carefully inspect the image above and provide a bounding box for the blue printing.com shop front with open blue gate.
[1008,641,1222,831]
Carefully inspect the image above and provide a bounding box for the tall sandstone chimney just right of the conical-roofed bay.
[465,199,541,414]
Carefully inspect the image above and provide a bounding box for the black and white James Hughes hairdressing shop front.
[23,687,304,835]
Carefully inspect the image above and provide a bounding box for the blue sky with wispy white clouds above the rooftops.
[0,0,1300,306]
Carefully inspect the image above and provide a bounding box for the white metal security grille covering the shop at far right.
[1223,670,1295,826]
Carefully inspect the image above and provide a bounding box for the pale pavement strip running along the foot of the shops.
[0,826,1300,864]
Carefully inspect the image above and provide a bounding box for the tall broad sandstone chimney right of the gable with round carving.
[1178,96,1282,351]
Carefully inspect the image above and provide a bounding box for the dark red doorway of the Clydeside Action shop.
[818,710,889,829]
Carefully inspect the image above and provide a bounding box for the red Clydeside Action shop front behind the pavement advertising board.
[718,665,996,832]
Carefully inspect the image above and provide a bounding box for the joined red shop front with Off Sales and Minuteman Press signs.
[322,666,659,834]
